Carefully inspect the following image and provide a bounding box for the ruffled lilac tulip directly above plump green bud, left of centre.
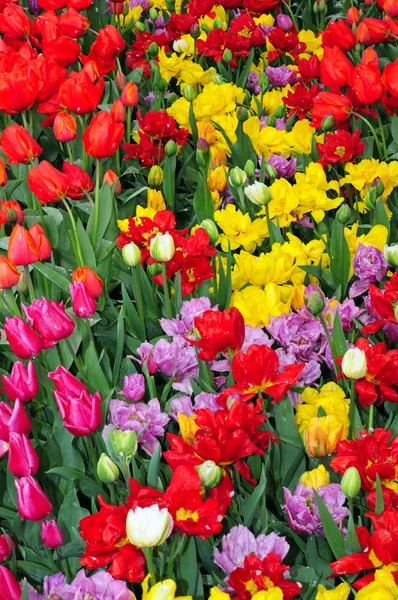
[109,398,170,455]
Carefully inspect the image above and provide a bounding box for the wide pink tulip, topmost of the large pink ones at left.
[22,298,75,343]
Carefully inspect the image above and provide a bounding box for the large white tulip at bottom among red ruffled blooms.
[126,504,174,548]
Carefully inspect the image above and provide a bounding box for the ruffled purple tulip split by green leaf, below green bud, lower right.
[283,483,349,537]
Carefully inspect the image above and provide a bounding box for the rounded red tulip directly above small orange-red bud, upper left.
[59,70,104,115]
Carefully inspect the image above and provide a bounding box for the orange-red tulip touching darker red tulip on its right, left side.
[28,160,68,204]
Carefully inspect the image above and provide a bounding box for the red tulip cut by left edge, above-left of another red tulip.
[0,124,43,165]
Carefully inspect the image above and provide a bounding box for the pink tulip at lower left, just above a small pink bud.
[15,475,52,521]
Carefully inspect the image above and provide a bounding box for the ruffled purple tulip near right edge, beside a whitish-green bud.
[349,243,388,298]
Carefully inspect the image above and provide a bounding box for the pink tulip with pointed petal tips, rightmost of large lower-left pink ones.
[53,390,102,437]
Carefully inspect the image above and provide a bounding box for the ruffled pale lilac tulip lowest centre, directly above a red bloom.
[214,525,290,575]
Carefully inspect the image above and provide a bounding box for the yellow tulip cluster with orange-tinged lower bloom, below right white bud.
[295,381,350,457]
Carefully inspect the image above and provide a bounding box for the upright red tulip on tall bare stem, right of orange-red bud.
[83,110,124,158]
